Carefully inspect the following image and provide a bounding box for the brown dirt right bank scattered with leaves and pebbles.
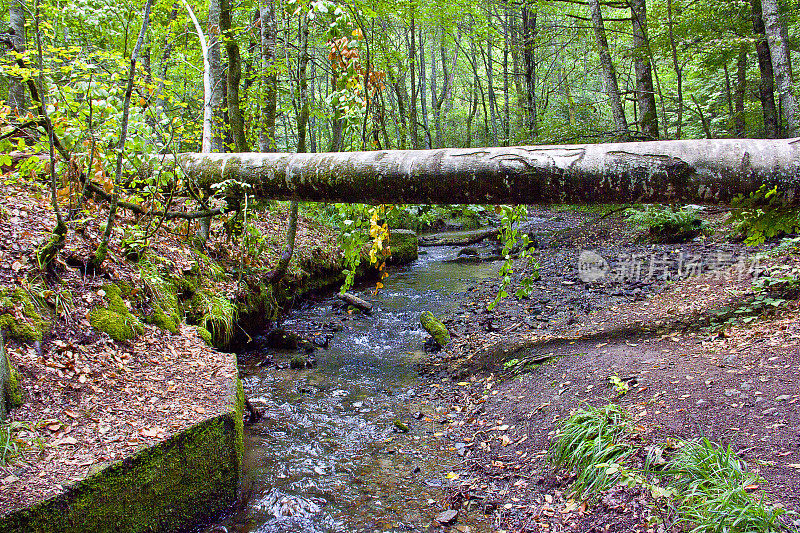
[418,209,800,532]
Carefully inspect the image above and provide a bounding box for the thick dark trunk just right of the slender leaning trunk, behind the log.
[630,0,658,140]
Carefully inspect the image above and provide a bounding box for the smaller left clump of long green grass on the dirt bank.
[550,404,634,499]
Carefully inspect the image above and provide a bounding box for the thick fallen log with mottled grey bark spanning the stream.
[172,139,800,205]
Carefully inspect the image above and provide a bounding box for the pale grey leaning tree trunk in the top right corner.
[761,0,800,137]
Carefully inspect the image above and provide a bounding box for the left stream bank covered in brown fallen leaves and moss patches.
[0,174,340,516]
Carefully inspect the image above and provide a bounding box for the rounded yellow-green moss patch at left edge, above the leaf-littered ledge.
[0,287,51,341]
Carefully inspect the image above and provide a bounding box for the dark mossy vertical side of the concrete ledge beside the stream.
[0,377,244,533]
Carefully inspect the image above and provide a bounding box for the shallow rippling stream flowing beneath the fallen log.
[203,247,497,533]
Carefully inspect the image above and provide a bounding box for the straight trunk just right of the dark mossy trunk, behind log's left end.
[258,0,280,152]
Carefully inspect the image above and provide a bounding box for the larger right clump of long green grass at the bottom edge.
[669,438,784,533]
